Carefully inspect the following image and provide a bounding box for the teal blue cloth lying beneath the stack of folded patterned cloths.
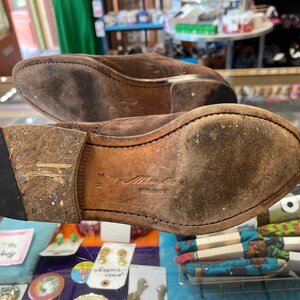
[160,232,300,300]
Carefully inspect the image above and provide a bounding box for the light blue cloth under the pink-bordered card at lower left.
[0,218,57,284]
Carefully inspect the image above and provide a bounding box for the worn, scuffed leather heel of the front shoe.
[0,125,87,223]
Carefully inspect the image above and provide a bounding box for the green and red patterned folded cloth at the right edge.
[257,220,300,237]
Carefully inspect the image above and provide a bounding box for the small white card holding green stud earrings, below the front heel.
[40,239,84,256]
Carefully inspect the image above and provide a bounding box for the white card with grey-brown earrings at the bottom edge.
[128,265,168,300]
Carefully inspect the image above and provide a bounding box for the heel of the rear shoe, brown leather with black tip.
[171,79,237,113]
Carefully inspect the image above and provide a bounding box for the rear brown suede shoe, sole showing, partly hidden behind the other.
[13,53,237,122]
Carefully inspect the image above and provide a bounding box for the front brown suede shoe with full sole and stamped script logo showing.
[0,104,300,234]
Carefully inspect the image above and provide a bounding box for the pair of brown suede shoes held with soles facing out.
[0,53,300,235]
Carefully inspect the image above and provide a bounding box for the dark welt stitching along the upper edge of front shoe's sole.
[87,112,300,148]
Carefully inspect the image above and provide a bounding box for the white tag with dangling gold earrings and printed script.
[87,243,135,290]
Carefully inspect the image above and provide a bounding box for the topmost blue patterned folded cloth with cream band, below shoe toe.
[175,230,259,255]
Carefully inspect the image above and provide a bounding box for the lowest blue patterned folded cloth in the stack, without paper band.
[181,257,287,277]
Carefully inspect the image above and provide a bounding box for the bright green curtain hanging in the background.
[53,0,101,54]
